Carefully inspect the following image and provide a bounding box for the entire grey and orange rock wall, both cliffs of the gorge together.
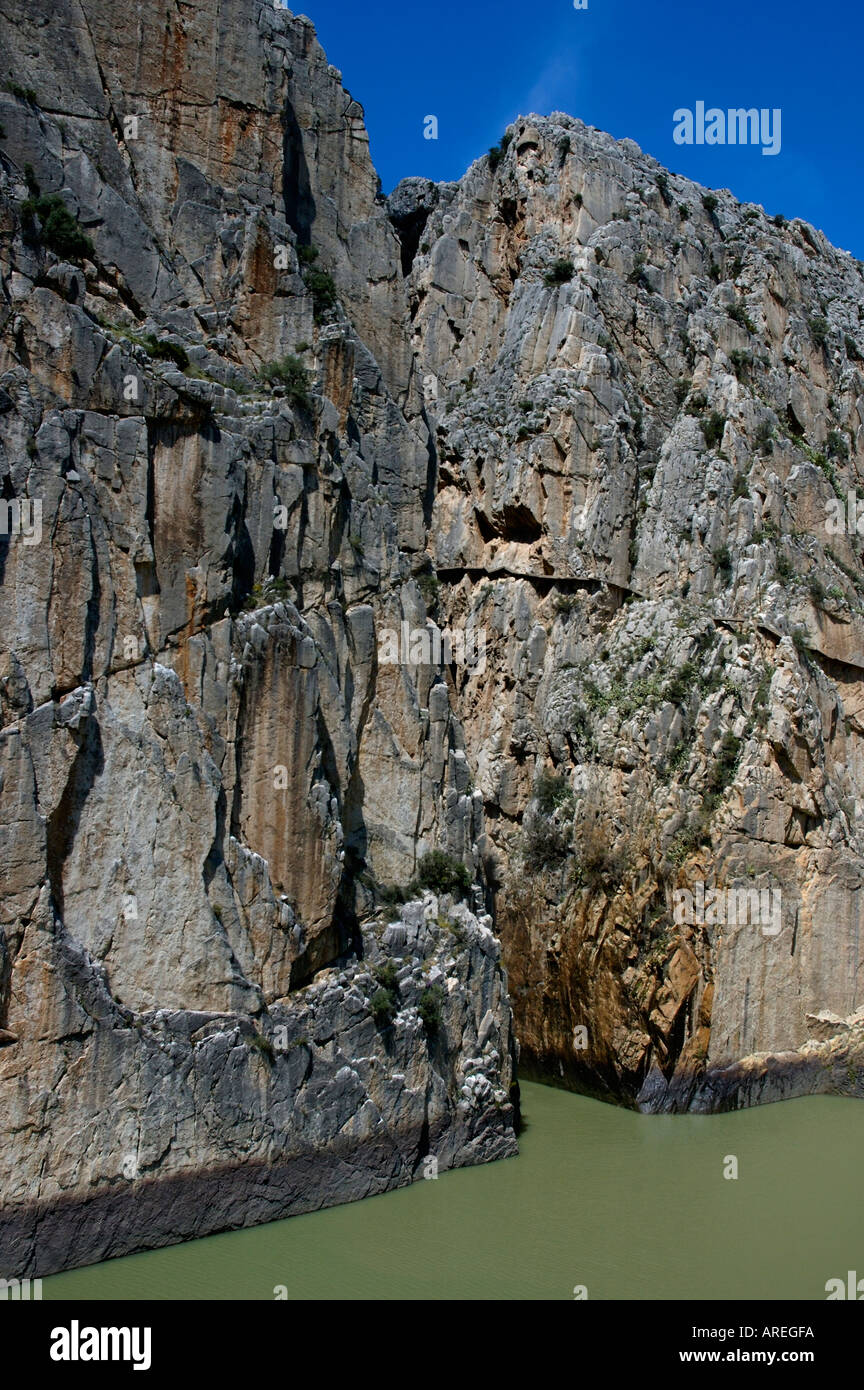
[0,0,864,1276]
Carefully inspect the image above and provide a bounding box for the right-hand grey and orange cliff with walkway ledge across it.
[392,115,864,1109]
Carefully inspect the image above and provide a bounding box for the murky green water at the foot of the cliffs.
[44,1084,864,1300]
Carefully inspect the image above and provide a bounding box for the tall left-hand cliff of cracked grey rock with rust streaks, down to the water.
[0,0,515,1273]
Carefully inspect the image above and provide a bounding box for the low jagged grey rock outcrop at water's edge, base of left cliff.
[0,895,514,1273]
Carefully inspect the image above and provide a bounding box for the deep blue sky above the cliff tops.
[302,0,864,259]
